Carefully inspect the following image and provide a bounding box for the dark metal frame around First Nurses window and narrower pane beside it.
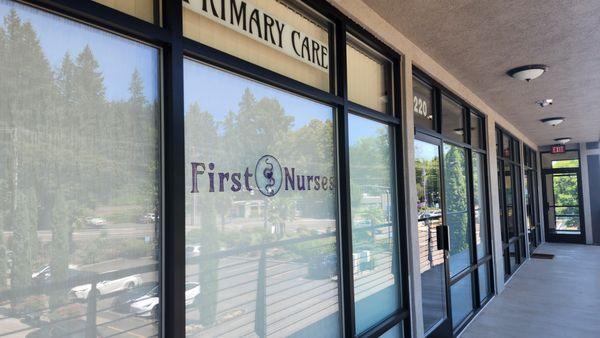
[19,0,411,337]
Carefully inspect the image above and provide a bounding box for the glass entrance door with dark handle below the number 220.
[415,135,452,337]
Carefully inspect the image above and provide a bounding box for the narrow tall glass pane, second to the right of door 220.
[473,153,489,259]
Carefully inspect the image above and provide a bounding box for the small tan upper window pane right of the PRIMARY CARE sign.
[346,34,392,113]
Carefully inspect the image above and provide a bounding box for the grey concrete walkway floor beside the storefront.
[460,244,600,338]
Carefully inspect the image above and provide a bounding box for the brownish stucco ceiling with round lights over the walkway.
[363,0,600,145]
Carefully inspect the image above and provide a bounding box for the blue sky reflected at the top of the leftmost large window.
[0,0,159,100]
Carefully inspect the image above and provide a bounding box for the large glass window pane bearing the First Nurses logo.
[184,60,342,337]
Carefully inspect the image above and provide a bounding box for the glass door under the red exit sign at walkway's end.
[544,172,585,243]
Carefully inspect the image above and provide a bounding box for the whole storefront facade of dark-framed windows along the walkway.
[0,0,556,337]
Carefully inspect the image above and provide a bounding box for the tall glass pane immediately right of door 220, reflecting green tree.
[444,143,471,276]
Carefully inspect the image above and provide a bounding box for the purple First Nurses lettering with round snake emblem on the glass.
[191,155,335,197]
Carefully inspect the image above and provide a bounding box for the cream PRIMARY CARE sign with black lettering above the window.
[183,0,329,72]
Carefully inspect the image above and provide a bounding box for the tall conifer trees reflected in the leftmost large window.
[0,9,159,307]
